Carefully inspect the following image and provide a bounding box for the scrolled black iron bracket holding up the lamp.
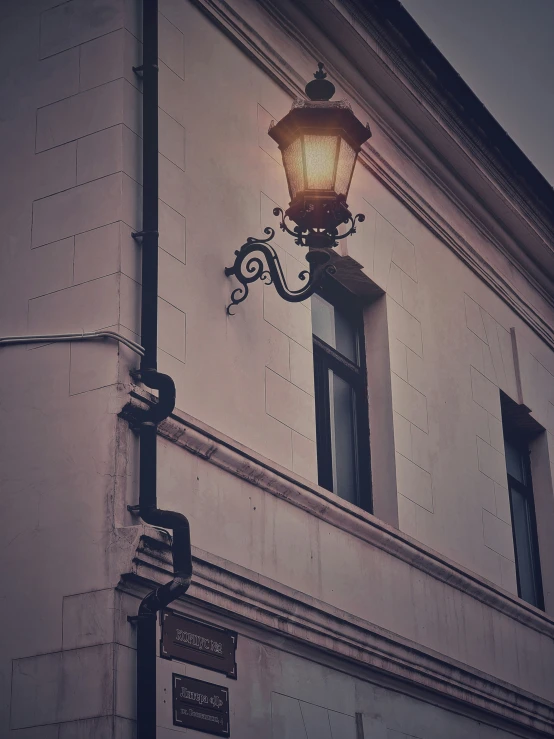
[225,208,365,316]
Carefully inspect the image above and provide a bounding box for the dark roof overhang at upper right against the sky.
[280,0,554,294]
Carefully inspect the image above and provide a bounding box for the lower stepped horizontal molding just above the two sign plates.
[119,529,554,737]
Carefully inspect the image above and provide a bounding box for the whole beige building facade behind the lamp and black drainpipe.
[0,0,554,739]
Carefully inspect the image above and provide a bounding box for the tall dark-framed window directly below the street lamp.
[312,280,371,510]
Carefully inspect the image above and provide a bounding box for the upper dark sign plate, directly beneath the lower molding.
[161,611,237,679]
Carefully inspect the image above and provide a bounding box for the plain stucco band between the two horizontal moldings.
[152,440,554,700]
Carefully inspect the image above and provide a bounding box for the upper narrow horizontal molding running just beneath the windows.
[120,391,554,638]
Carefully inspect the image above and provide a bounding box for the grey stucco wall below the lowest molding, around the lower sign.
[152,624,515,739]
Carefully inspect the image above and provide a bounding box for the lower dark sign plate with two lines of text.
[172,674,231,736]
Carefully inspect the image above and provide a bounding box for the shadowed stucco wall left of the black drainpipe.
[0,0,141,739]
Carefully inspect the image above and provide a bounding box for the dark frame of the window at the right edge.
[504,432,544,611]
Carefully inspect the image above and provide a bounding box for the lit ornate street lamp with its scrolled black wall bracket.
[225,62,371,315]
